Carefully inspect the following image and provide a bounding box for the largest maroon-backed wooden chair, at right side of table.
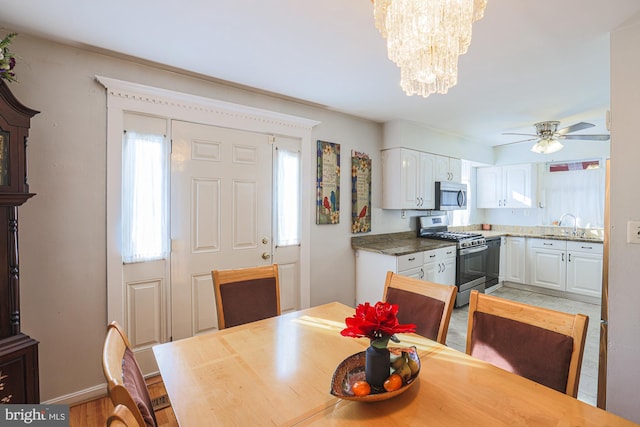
[466,291,589,397]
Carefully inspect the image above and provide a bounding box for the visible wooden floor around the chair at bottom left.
[69,376,178,427]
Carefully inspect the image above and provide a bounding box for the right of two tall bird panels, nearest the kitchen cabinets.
[351,150,371,233]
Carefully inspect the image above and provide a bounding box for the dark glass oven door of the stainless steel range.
[456,245,488,307]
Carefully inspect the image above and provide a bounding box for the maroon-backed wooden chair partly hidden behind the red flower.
[382,271,458,344]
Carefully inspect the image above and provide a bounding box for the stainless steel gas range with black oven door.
[418,215,488,307]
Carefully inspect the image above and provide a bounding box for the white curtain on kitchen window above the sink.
[544,165,605,228]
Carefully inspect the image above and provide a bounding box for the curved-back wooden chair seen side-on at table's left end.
[102,321,158,427]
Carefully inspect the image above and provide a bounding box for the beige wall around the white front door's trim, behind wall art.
[11,34,390,402]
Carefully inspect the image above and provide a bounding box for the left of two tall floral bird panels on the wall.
[316,141,340,224]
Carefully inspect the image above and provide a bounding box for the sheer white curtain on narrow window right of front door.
[275,148,300,246]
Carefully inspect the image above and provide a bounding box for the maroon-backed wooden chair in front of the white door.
[211,264,280,329]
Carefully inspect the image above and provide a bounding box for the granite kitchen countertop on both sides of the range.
[351,230,603,256]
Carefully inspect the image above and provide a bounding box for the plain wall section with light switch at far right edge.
[594,10,640,422]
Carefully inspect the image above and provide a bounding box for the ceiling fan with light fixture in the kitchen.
[500,120,610,154]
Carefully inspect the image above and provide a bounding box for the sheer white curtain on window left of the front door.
[122,131,169,263]
